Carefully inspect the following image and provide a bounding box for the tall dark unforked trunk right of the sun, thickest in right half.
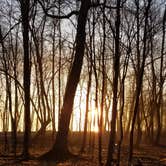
[106,0,121,166]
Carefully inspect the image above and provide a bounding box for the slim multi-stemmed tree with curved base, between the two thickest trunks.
[30,11,51,140]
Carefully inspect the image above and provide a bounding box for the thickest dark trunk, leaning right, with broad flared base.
[41,0,91,160]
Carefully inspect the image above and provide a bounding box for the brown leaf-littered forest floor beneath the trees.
[0,134,166,166]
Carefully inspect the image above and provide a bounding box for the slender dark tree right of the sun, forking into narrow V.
[128,0,152,165]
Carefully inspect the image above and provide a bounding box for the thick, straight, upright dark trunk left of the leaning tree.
[20,0,31,158]
